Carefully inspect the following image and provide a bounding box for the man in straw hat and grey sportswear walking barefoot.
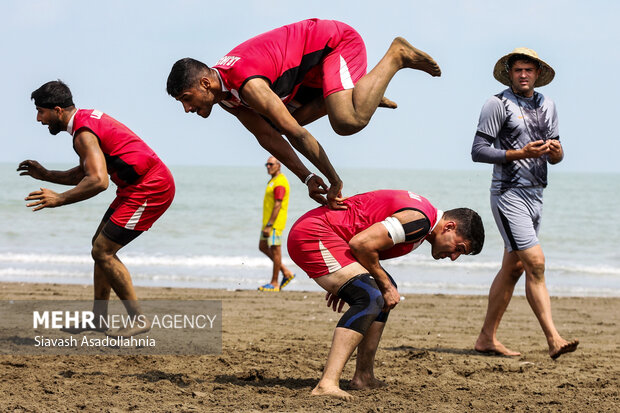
[471,47,579,359]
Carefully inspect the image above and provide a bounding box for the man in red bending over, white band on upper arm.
[287,190,484,400]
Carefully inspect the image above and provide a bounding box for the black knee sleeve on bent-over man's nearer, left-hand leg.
[337,274,387,334]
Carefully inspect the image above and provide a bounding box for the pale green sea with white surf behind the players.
[0,163,620,296]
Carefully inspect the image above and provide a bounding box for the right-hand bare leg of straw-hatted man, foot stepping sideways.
[517,244,579,359]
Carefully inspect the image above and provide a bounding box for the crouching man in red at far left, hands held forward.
[17,81,175,337]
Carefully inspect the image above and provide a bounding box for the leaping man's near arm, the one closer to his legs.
[242,78,346,209]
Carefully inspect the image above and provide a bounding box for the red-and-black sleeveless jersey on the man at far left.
[69,109,165,188]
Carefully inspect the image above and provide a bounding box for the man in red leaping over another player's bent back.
[167,19,441,209]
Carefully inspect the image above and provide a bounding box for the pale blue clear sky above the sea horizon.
[0,0,620,173]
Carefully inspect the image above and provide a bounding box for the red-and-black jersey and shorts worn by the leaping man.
[213,19,366,107]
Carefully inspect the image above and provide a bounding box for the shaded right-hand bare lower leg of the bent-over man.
[349,321,387,390]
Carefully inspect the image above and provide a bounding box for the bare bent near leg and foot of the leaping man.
[325,37,441,135]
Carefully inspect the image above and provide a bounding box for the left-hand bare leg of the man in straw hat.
[474,250,523,356]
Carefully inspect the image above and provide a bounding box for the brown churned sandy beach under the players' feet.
[0,283,620,412]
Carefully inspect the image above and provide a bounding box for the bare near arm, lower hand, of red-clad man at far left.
[26,131,108,211]
